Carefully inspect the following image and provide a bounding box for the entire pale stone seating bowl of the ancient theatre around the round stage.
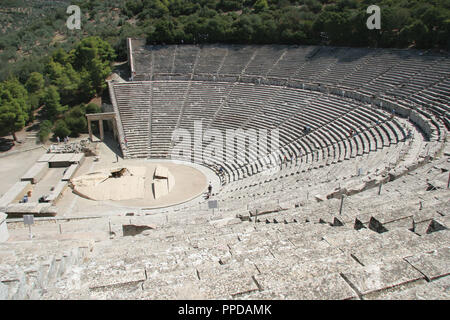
[0,39,450,299]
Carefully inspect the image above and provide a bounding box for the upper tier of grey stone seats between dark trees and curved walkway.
[129,45,448,109]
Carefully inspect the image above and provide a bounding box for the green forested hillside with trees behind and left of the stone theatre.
[0,0,450,145]
